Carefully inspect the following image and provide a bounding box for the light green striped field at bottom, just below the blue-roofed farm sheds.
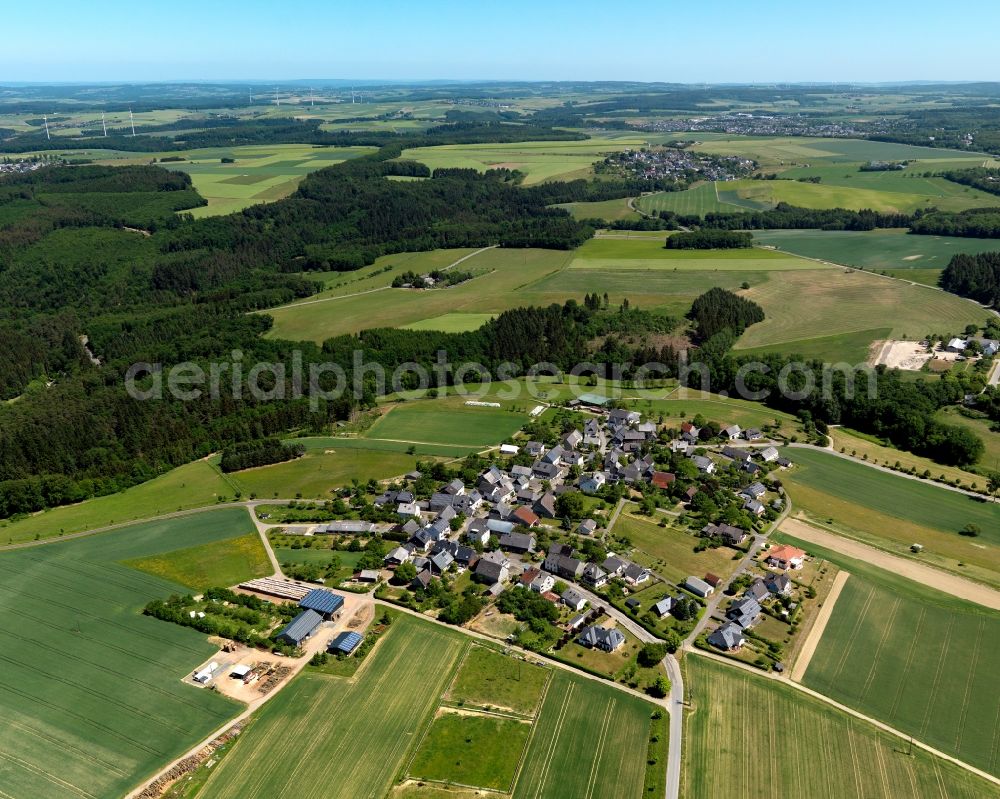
[198,616,463,799]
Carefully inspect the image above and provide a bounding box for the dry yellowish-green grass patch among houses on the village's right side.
[614,513,737,583]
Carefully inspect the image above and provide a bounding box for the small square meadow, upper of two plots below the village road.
[445,646,550,716]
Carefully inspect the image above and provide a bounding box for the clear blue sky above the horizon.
[7,0,1000,83]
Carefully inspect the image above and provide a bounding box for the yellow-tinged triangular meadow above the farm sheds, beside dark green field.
[125,518,272,591]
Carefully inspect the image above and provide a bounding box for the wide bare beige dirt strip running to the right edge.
[780,519,1000,610]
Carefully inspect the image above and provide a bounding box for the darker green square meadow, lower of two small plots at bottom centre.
[409,710,531,791]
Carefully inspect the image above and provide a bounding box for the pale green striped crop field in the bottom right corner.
[682,652,1000,799]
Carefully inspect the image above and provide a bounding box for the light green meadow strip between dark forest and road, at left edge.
[0,461,234,545]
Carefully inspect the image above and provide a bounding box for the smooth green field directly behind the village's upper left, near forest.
[365,397,528,454]
